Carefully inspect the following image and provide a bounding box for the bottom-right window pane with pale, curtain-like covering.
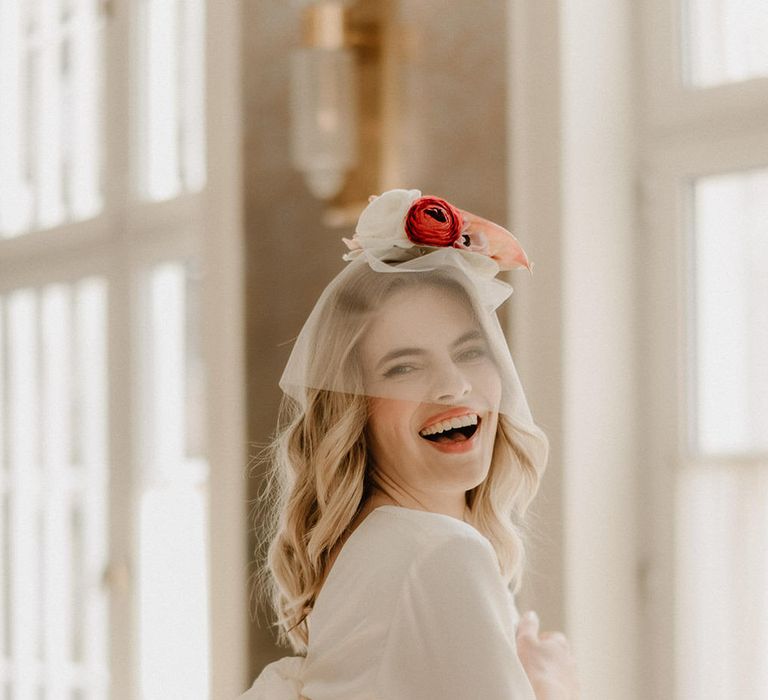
[675,464,768,700]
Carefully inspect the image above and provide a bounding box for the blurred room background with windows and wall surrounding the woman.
[0,0,768,700]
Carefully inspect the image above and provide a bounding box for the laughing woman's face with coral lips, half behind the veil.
[360,287,501,497]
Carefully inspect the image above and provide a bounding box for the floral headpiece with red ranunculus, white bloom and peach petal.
[342,190,533,275]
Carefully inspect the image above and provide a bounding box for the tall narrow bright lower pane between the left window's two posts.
[139,263,209,700]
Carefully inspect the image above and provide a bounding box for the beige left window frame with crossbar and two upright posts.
[0,0,248,700]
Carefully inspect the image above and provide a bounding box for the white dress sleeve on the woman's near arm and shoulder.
[376,536,535,700]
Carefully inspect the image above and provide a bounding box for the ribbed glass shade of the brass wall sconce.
[290,47,358,200]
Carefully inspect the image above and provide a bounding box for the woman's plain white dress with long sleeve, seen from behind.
[238,505,535,700]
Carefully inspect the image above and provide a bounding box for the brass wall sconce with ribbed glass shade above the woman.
[290,0,382,225]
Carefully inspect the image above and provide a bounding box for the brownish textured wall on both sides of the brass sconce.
[242,0,507,675]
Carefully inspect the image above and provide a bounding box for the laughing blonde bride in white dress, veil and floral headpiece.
[241,190,576,700]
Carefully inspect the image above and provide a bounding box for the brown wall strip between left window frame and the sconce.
[242,1,336,678]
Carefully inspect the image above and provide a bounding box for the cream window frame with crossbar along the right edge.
[639,0,768,698]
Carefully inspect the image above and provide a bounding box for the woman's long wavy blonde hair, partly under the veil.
[253,265,547,653]
